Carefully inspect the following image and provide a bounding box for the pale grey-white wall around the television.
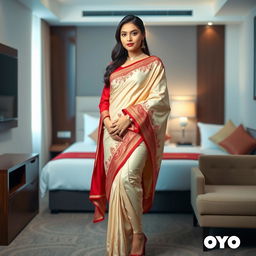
[0,0,32,153]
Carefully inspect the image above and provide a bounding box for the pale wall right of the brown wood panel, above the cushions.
[225,9,256,128]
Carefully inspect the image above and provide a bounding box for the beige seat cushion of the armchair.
[196,185,256,216]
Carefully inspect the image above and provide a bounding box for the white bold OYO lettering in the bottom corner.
[204,236,241,249]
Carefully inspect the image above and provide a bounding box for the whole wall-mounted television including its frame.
[0,43,18,131]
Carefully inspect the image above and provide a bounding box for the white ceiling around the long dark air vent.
[17,0,256,26]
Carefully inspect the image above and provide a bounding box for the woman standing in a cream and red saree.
[90,15,170,256]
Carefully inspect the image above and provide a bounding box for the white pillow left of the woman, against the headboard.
[83,113,100,145]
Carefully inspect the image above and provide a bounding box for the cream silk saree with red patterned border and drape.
[90,56,170,256]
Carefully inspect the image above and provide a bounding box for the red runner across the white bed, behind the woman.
[52,152,200,160]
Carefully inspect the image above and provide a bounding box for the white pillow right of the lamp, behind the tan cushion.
[197,122,224,149]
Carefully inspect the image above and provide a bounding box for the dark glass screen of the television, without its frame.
[0,53,18,122]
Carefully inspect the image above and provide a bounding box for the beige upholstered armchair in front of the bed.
[191,155,256,249]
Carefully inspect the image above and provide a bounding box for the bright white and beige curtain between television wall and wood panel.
[31,15,51,170]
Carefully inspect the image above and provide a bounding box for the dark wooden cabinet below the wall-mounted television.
[0,154,39,245]
